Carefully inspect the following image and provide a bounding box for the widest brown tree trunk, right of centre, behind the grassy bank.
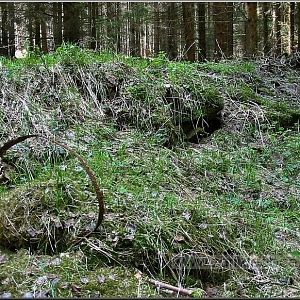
[213,2,233,59]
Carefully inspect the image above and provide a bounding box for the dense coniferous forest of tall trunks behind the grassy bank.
[0,1,300,61]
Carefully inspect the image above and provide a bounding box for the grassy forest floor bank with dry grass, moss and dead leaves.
[0,46,300,298]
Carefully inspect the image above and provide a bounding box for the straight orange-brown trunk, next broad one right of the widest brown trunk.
[245,2,258,55]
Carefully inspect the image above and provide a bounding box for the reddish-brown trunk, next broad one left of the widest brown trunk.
[182,2,195,61]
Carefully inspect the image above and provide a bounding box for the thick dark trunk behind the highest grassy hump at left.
[63,2,80,44]
